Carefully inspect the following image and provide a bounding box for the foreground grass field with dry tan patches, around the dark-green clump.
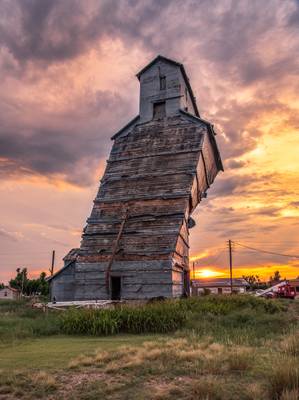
[0,296,299,400]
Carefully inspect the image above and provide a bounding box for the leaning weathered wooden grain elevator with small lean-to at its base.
[50,56,223,301]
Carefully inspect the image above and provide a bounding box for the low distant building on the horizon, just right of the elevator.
[191,278,249,296]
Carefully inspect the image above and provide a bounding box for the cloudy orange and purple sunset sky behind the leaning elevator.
[0,0,299,282]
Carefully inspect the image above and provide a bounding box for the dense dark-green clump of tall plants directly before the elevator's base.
[61,301,187,335]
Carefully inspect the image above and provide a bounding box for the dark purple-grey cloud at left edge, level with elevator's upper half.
[0,129,101,185]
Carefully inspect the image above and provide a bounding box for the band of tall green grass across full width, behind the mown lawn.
[0,296,298,342]
